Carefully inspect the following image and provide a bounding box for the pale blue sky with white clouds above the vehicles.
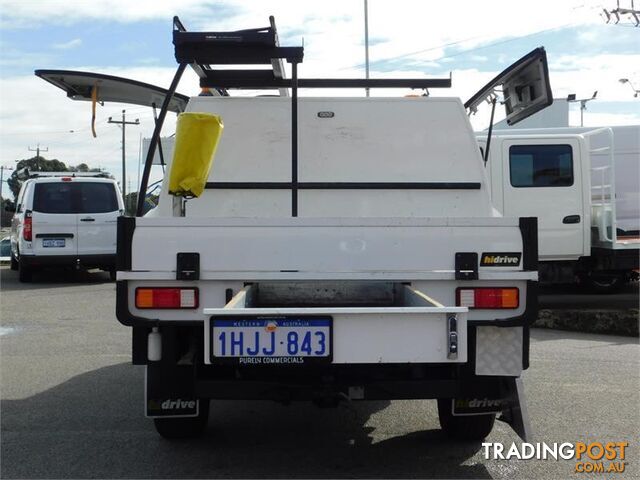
[0,0,640,196]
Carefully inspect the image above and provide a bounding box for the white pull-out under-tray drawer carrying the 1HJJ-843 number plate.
[204,283,468,365]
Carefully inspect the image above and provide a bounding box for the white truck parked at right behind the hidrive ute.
[478,125,640,293]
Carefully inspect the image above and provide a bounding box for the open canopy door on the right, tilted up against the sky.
[464,47,553,125]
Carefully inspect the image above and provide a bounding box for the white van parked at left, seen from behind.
[11,172,124,282]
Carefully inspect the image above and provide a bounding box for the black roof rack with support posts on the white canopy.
[136,17,451,217]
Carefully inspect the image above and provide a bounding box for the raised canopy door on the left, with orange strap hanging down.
[35,70,189,113]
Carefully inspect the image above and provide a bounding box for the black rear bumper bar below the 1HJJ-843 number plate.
[192,364,505,403]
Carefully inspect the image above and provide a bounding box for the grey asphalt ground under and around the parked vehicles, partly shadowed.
[0,267,640,479]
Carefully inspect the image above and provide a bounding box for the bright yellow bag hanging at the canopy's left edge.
[169,113,224,197]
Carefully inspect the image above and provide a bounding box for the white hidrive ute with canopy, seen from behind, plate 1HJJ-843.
[36,18,551,439]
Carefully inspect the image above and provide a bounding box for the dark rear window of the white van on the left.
[33,182,118,213]
